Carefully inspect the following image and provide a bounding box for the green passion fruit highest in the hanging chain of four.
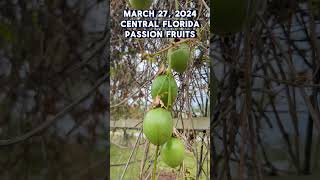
[167,44,191,73]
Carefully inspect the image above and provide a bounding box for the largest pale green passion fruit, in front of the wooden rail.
[143,108,173,145]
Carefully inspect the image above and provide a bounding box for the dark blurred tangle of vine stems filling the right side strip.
[210,0,320,180]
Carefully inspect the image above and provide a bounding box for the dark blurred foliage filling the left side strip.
[0,0,108,180]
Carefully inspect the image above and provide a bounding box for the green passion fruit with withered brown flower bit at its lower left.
[151,75,178,107]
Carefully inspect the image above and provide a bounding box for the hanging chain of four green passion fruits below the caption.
[143,40,191,168]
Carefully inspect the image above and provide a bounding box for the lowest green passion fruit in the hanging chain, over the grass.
[161,138,184,168]
